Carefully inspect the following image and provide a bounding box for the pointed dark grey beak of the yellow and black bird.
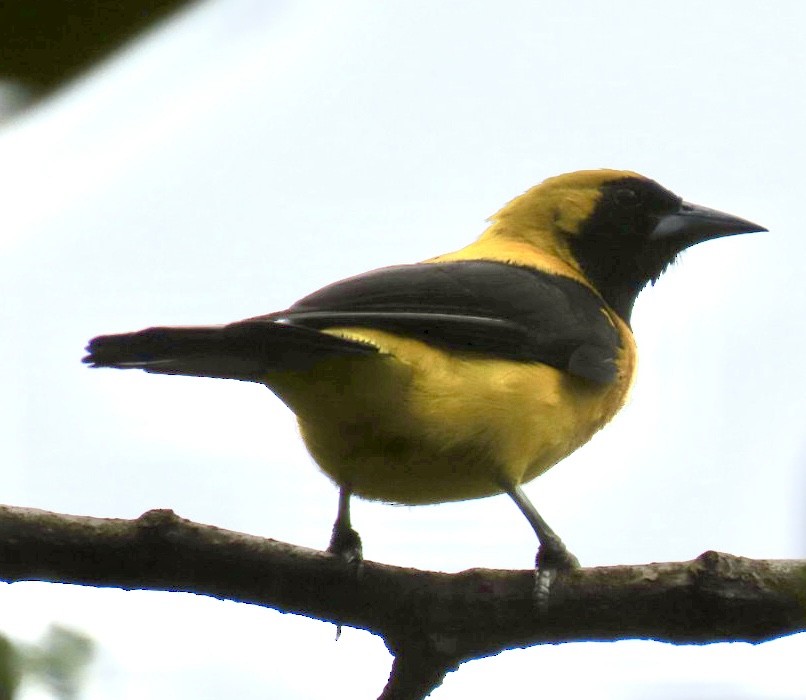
[649,202,767,248]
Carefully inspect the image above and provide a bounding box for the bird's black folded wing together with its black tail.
[83,261,619,383]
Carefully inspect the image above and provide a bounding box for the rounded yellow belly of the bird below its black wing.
[266,329,633,505]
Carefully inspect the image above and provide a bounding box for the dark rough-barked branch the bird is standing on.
[0,506,806,700]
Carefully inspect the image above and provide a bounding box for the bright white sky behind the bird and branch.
[0,0,806,700]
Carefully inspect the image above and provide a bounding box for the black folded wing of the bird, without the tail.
[262,261,620,383]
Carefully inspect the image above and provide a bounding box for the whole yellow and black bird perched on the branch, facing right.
[83,169,766,605]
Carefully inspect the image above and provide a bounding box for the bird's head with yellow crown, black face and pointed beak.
[491,170,766,320]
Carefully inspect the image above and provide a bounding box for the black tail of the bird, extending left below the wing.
[82,320,377,381]
